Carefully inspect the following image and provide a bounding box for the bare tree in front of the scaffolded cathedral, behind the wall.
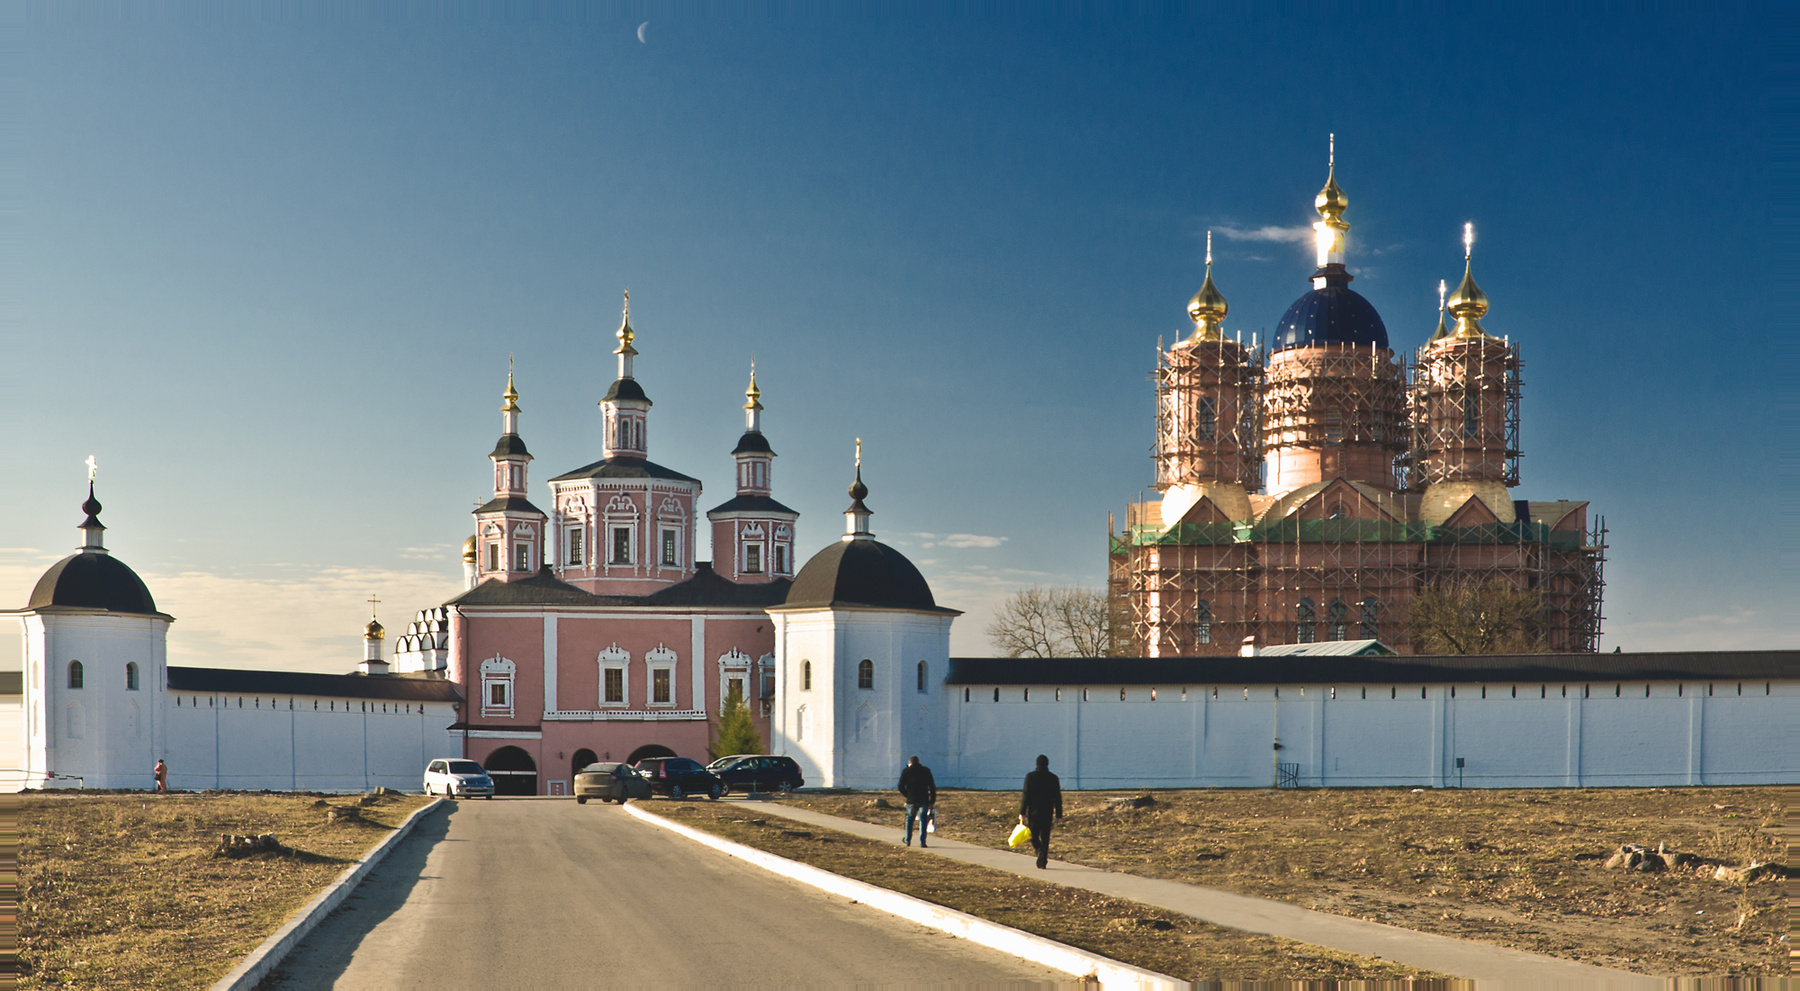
[1406,577,1548,655]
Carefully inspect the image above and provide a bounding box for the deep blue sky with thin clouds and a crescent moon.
[0,4,1778,671]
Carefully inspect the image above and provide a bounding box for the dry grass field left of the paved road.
[18,791,425,987]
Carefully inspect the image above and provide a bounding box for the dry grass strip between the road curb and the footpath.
[644,802,1449,987]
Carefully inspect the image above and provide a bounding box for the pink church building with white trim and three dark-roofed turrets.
[394,295,799,795]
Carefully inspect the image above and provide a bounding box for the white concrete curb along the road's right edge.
[625,804,1192,989]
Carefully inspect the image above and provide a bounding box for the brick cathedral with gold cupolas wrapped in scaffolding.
[1109,149,1606,656]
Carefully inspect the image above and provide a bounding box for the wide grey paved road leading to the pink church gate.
[265,799,1071,989]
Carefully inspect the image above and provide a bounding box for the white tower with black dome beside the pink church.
[769,449,963,788]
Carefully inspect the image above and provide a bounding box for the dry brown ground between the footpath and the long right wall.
[785,788,1796,977]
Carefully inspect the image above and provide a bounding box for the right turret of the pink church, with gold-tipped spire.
[706,362,799,583]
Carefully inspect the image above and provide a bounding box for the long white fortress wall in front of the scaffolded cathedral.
[950,680,1800,790]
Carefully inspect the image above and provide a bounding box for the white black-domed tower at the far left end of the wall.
[7,478,170,788]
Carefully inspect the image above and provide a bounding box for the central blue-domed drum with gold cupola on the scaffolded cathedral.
[1262,138,1409,495]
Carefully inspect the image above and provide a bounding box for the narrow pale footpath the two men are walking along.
[727,797,1667,989]
